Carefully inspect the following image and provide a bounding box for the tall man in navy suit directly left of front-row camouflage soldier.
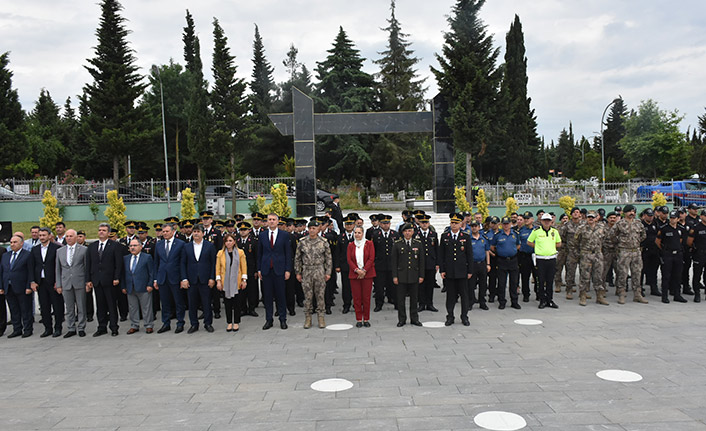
[257,214,292,329]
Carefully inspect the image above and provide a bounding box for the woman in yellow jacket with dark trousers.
[216,233,248,332]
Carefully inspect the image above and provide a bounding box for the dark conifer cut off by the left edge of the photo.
[0,52,31,176]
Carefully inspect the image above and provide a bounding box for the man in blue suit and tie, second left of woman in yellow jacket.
[154,223,186,334]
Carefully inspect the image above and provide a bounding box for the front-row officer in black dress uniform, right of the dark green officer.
[438,213,473,326]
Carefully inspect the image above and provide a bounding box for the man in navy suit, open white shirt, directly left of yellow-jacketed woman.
[183,223,216,334]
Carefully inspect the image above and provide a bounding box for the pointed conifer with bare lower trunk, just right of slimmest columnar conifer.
[211,18,252,214]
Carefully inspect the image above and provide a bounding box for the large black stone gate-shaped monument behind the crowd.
[268,88,456,217]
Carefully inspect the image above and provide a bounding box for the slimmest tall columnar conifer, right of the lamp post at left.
[182,10,214,211]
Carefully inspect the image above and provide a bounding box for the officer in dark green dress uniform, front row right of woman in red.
[390,223,425,328]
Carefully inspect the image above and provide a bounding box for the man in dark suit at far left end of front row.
[0,235,34,338]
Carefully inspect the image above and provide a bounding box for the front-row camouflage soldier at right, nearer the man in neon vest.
[575,211,608,305]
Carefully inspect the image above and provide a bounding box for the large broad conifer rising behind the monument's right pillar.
[432,0,502,195]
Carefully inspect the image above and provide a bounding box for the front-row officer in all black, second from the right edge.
[655,210,686,304]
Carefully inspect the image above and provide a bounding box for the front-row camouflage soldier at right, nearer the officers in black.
[615,205,647,304]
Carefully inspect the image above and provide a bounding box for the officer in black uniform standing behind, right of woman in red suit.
[372,214,400,312]
